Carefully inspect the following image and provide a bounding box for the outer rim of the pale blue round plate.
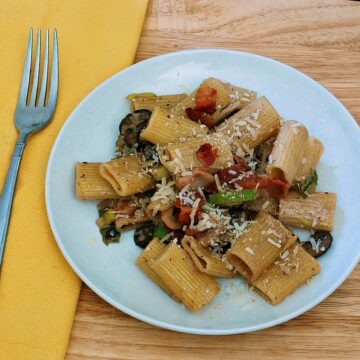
[45,48,360,335]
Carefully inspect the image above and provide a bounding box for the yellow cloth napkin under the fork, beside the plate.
[0,0,147,360]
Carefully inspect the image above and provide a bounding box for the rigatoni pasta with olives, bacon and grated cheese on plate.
[75,78,336,311]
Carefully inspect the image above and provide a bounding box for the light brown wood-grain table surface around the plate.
[66,0,360,360]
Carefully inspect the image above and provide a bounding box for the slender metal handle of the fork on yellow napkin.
[0,139,25,269]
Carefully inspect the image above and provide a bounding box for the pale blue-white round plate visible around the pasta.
[46,50,360,335]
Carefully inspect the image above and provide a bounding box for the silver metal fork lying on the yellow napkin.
[0,29,59,268]
